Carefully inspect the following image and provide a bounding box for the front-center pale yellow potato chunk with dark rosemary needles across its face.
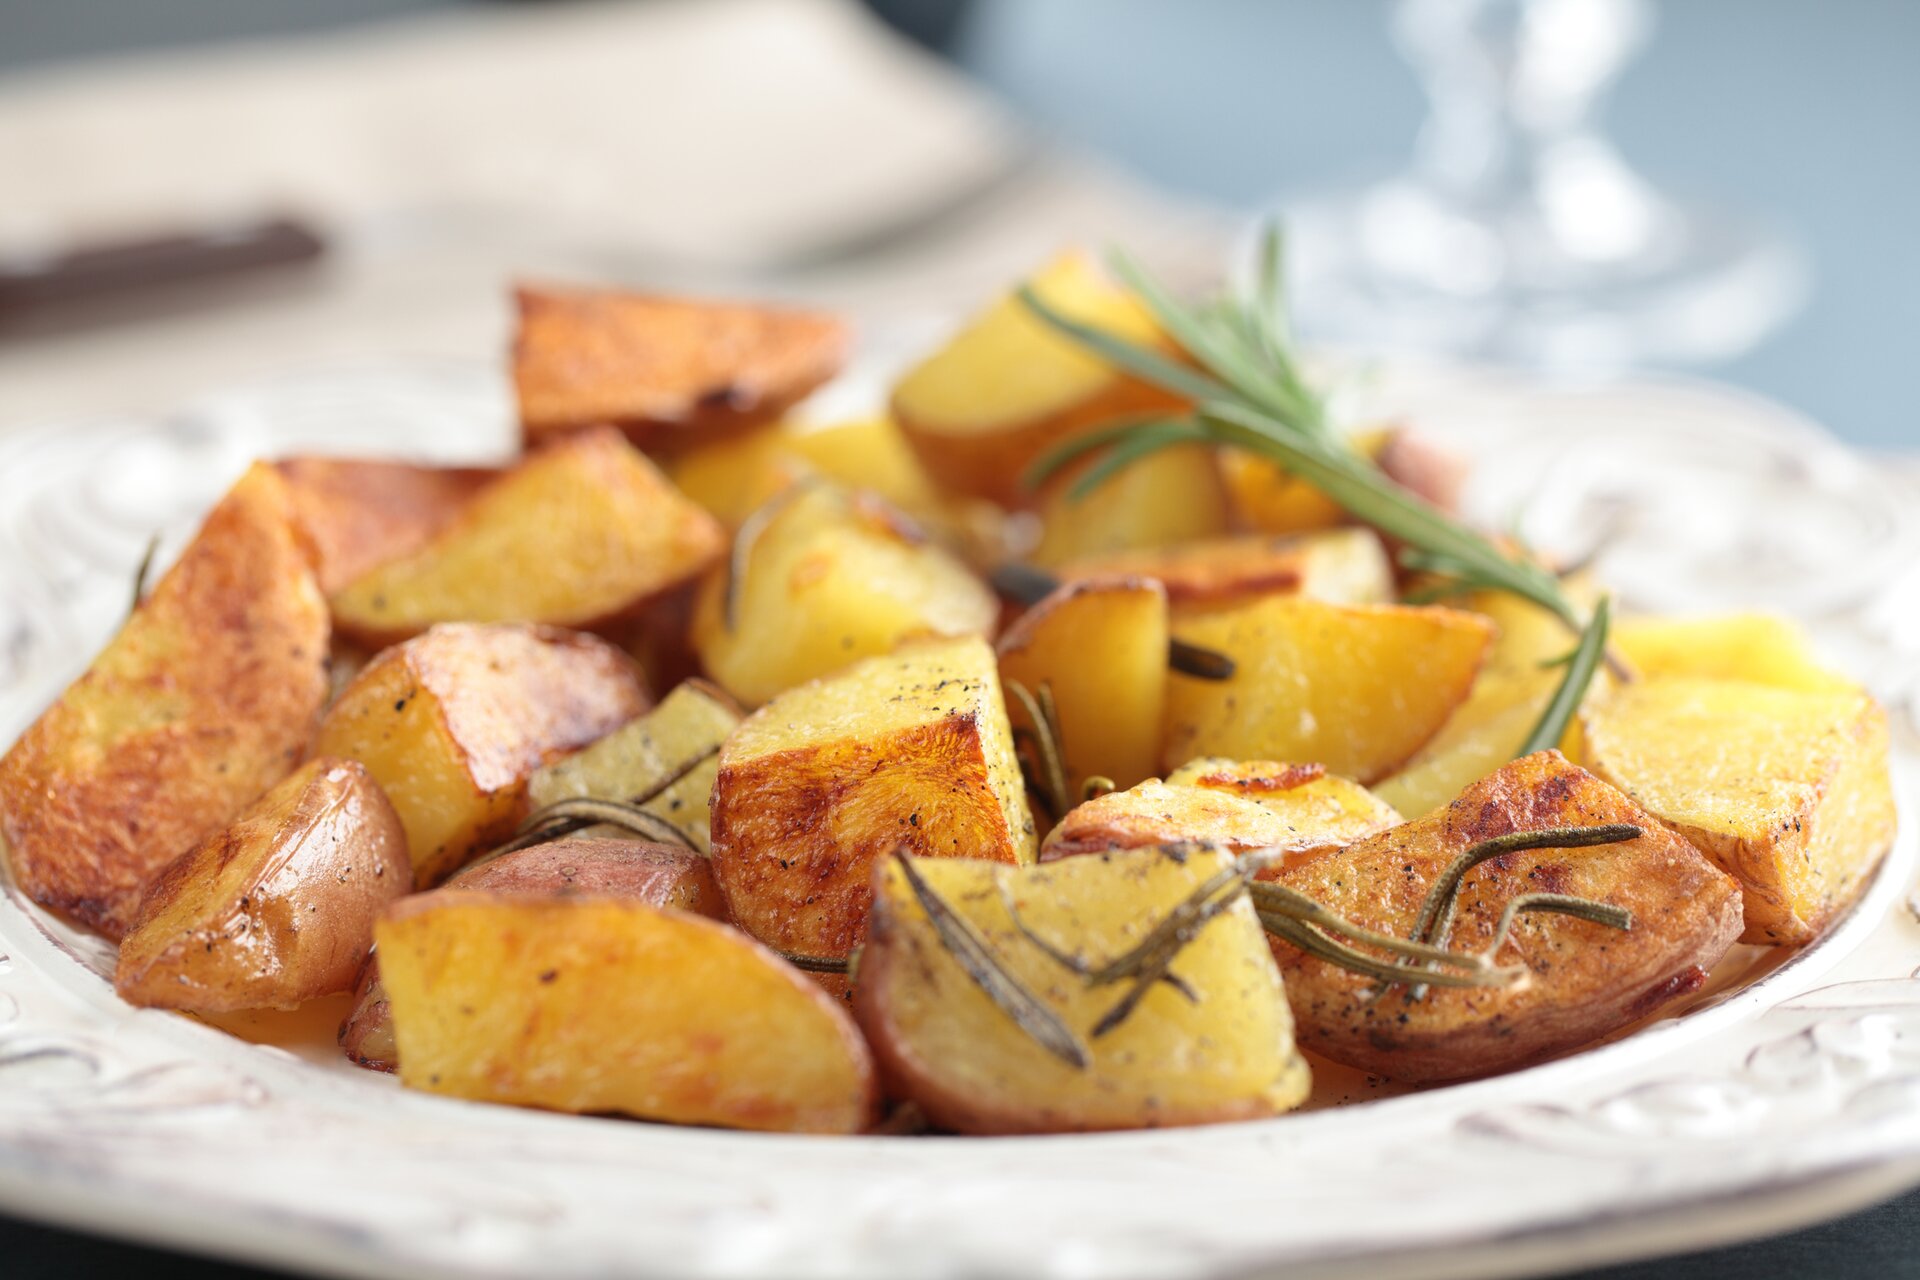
[854,848,1309,1134]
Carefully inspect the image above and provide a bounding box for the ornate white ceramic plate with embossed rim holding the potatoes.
[0,355,1920,1280]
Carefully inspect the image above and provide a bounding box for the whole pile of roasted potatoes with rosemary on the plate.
[0,253,1897,1134]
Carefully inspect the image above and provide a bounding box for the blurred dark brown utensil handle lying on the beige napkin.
[0,217,326,334]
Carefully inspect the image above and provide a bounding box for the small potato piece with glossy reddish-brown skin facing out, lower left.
[113,756,413,1013]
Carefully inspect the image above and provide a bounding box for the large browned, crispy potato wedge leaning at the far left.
[0,464,326,938]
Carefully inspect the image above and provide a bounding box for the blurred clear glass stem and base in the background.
[1288,0,1805,370]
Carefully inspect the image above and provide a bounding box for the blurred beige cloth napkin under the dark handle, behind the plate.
[0,0,1225,426]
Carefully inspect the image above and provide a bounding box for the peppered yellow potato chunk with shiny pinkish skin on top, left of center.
[313,624,647,889]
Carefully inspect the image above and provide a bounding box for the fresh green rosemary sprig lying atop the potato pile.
[1020,226,1584,631]
